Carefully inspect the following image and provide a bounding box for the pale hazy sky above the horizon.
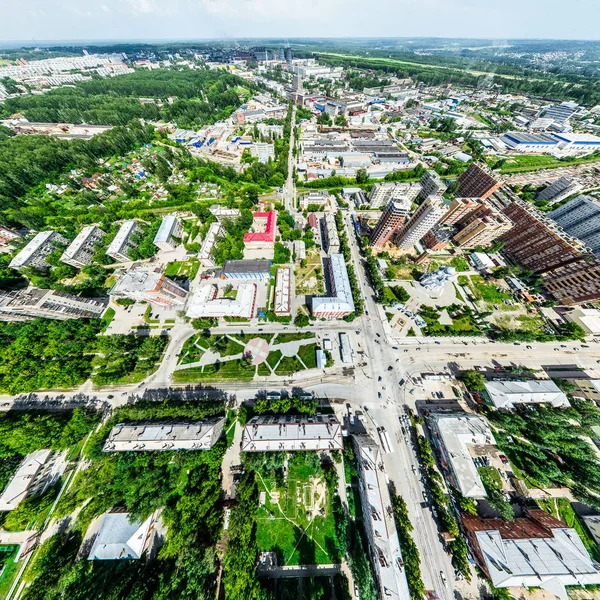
[0,0,600,44]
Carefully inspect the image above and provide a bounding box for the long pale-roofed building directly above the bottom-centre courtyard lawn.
[242,414,343,452]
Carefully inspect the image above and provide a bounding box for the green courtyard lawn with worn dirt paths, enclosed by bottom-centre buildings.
[256,452,337,565]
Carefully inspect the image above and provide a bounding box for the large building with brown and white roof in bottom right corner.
[462,509,600,600]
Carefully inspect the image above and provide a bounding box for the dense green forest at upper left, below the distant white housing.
[0,69,252,127]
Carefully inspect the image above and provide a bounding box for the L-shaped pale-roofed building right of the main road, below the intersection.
[428,412,496,498]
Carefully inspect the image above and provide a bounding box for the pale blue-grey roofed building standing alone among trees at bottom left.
[88,512,154,560]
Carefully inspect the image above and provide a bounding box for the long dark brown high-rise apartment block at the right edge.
[499,200,600,304]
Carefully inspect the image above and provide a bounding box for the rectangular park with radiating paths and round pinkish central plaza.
[173,332,319,383]
